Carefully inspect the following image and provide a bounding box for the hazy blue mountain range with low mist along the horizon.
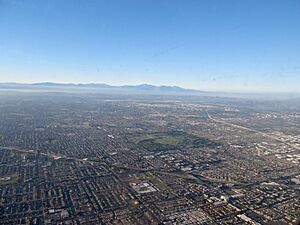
[0,82,300,100]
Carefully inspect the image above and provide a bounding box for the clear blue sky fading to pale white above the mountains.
[0,0,300,92]
